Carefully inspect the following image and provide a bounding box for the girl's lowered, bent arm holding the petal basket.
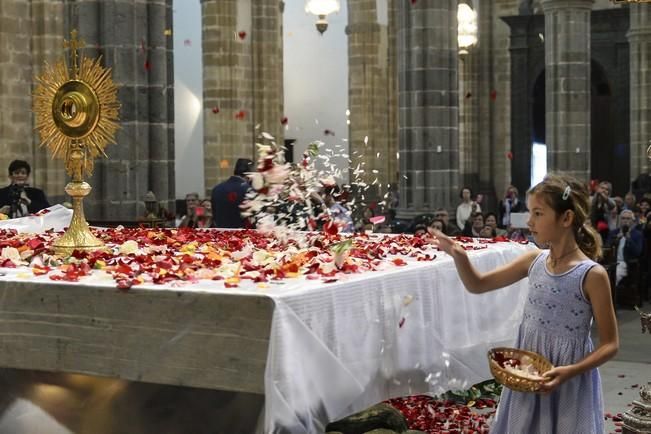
[541,265,619,392]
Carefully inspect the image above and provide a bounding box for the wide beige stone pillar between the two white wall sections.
[201,0,283,192]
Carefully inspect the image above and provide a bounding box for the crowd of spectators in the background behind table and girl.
[5,158,651,302]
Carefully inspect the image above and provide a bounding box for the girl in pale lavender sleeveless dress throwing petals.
[434,175,619,434]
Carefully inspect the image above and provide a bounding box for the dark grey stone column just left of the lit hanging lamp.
[398,0,459,218]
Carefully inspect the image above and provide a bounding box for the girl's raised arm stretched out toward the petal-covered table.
[432,230,540,294]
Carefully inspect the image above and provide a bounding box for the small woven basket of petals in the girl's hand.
[488,347,554,392]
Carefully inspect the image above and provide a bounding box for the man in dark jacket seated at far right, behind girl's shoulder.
[606,210,644,285]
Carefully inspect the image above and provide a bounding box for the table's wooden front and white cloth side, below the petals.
[0,212,531,433]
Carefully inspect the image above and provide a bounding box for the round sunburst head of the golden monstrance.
[34,53,120,176]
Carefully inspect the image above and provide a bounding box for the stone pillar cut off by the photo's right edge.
[628,4,651,180]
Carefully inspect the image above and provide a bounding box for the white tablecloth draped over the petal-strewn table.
[2,209,532,433]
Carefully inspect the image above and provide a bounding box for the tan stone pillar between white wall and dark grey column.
[346,0,398,200]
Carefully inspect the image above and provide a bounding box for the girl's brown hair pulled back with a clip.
[527,174,601,260]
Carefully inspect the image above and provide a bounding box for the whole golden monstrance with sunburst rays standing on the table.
[33,30,120,255]
